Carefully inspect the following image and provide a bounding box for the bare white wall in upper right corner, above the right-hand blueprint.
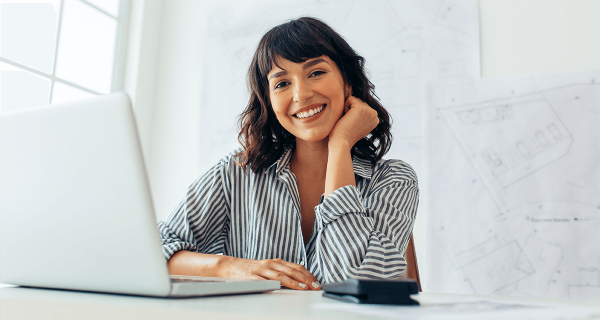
[479,0,600,77]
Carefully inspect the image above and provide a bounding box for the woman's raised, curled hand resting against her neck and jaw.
[329,96,379,148]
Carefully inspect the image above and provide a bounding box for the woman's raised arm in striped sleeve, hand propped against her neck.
[311,97,418,282]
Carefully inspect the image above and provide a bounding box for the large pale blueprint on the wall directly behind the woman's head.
[199,0,479,176]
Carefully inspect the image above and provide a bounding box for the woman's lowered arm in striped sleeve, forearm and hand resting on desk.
[158,154,320,290]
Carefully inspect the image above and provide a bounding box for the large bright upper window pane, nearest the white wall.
[56,0,117,93]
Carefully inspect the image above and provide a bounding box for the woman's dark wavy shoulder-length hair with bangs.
[236,17,392,173]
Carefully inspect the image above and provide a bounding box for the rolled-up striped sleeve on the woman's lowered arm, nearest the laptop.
[158,160,229,260]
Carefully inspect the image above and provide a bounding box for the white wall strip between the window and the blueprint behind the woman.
[125,0,282,219]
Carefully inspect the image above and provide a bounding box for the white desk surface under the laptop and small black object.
[0,287,600,320]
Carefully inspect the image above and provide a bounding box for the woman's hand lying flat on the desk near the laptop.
[219,256,321,290]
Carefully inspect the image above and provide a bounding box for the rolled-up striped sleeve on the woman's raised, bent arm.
[311,160,419,283]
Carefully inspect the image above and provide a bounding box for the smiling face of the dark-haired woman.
[267,56,351,141]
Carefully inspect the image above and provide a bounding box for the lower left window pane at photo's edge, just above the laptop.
[0,63,50,113]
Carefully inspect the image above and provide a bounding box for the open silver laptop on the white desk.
[0,93,280,297]
